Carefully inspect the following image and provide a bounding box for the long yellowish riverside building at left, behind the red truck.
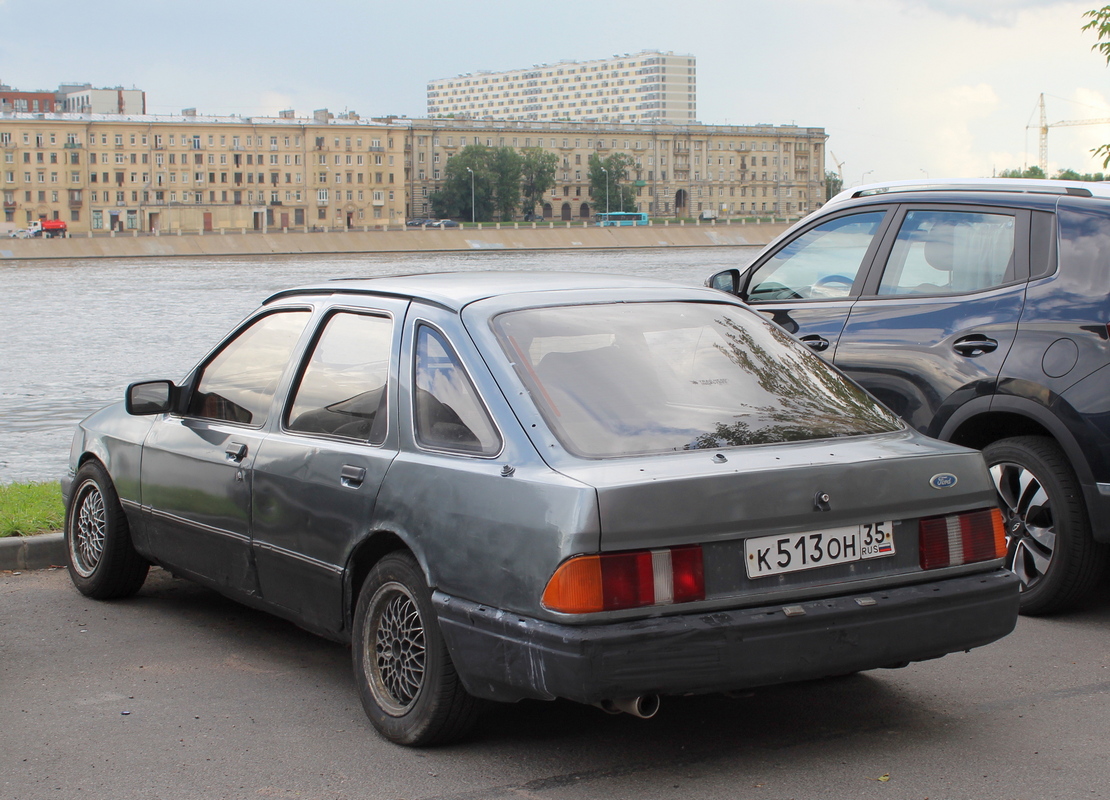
[0,110,405,234]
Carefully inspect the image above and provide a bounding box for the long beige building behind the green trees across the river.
[397,119,827,221]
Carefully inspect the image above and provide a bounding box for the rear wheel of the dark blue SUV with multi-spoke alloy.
[982,436,1110,616]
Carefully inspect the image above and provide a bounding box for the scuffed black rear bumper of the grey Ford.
[433,569,1018,702]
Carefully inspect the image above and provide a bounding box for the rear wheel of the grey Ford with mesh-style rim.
[351,551,478,747]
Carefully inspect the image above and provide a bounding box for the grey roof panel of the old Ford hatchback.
[265,271,703,311]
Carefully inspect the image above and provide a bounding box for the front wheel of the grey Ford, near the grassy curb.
[65,462,150,600]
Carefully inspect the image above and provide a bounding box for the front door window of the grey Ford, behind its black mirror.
[188,311,311,426]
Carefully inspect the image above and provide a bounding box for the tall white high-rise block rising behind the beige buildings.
[427,50,697,124]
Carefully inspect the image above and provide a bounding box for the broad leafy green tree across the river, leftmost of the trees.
[432,144,521,222]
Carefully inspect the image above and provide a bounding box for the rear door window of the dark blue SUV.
[879,210,1016,295]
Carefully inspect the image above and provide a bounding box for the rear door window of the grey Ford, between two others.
[286,312,393,444]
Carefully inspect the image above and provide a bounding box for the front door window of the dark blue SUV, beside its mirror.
[748,211,886,303]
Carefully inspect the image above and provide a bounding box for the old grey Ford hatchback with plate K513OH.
[63,272,1018,745]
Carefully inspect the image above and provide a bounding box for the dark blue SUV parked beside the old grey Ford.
[708,180,1110,614]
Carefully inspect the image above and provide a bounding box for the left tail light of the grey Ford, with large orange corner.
[543,545,705,614]
